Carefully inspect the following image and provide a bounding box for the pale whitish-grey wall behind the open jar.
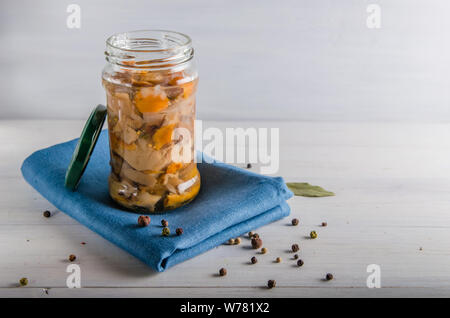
[0,0,450,122]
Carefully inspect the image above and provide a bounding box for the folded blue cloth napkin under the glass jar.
[22,131,292,272]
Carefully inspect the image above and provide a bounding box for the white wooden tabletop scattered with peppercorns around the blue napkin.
[0,120,450,297]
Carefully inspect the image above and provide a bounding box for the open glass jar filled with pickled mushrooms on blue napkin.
[102,30,200,212]
